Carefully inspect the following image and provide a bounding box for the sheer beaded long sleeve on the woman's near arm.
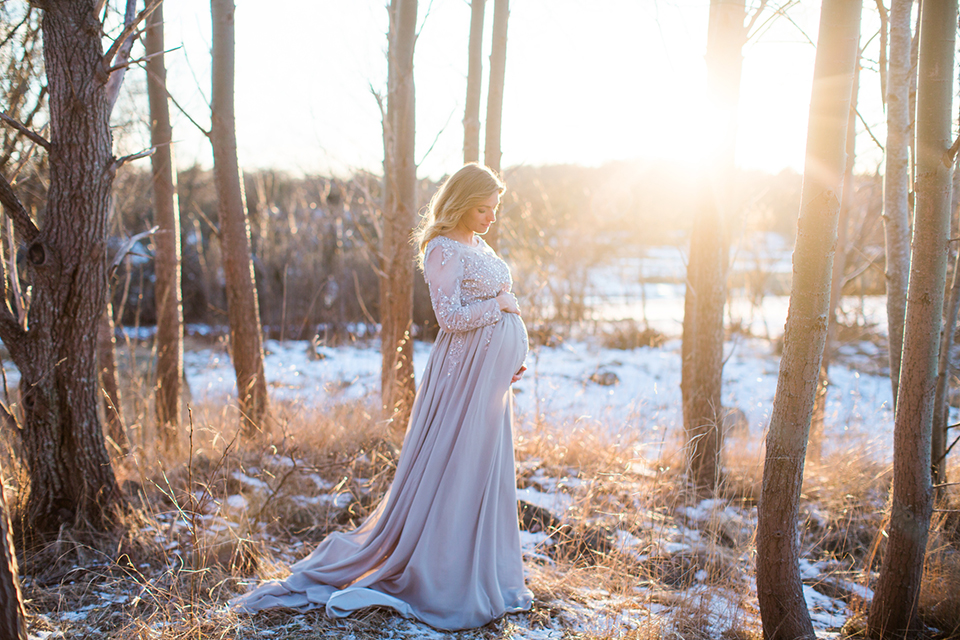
[423,242,501,333]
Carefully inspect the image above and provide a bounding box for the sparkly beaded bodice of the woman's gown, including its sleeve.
[423,236,513,333]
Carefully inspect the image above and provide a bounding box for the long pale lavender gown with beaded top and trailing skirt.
[231,236,533,630]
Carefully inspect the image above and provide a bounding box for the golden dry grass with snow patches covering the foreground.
[7,348,960,640]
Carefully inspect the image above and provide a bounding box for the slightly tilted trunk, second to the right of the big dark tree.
[210,0,268,437]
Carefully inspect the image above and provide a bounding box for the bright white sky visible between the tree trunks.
[124,0,882,177]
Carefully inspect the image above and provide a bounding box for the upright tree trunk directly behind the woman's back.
[380,0,417,428]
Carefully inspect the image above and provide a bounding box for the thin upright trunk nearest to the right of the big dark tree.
[145,4,183,450]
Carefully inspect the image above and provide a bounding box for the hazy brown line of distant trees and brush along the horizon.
[107,162,883,340]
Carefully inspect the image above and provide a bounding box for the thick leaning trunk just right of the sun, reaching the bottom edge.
[757,0,862,640]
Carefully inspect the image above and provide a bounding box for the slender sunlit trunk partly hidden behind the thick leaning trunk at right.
[806,54,860,462]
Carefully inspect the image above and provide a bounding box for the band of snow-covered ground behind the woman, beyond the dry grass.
[184,324,893,460]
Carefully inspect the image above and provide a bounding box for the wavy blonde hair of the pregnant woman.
[413,162,504,268]
